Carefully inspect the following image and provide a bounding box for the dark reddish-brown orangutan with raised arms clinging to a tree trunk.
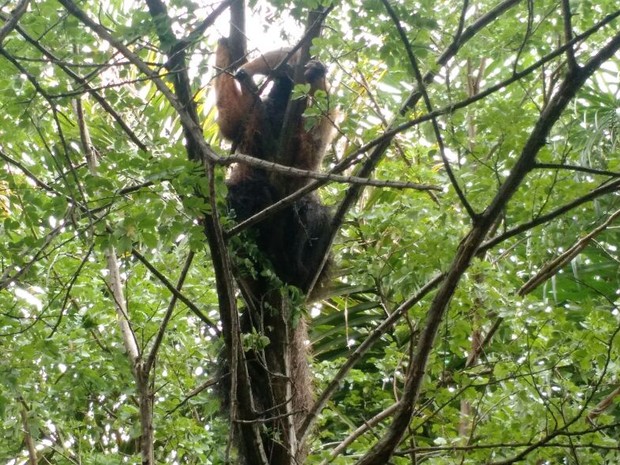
[215,39,333,292]
